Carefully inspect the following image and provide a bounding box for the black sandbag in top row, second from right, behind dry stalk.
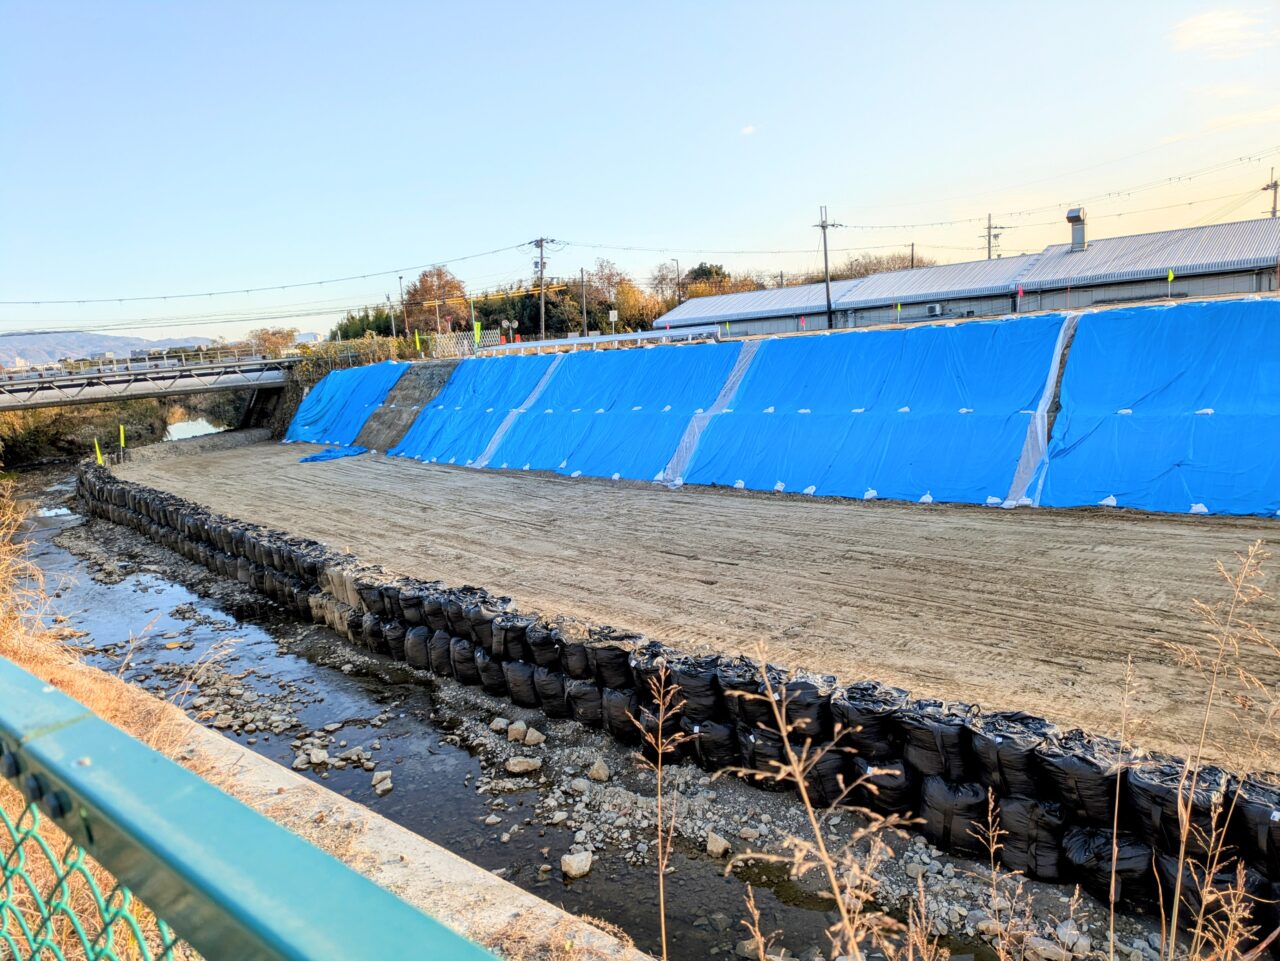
[1125,758,1228,860]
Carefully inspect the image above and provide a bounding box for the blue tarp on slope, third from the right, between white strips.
[488,343,741,480]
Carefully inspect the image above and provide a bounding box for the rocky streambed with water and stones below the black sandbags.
[23,455,1151,961]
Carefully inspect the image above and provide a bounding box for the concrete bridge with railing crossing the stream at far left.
[0,351,300,411]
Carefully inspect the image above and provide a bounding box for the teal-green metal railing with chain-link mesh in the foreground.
[0,658,493,961]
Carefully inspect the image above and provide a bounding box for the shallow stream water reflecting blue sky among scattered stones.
[31,499,844,961]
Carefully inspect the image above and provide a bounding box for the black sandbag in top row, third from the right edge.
[1036,728,1124,828]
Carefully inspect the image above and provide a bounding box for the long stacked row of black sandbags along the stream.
[78,466,1280,903]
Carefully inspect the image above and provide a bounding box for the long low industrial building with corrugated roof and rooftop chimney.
[654,207,1280,334]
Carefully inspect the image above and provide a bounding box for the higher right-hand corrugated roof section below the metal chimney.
[1020,218,1280,290]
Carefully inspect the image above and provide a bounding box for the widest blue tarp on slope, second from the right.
[684,315,1062,504]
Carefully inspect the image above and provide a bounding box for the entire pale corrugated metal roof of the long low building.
[654,218,1280,328]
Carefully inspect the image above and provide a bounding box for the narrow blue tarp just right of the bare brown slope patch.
[387,354,554,465]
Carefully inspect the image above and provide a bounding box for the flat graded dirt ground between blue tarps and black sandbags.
[120,444,1280,768]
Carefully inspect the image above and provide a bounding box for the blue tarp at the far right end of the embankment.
[1041,301,1280,514]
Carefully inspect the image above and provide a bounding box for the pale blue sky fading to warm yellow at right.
[0,0,1280,338]
